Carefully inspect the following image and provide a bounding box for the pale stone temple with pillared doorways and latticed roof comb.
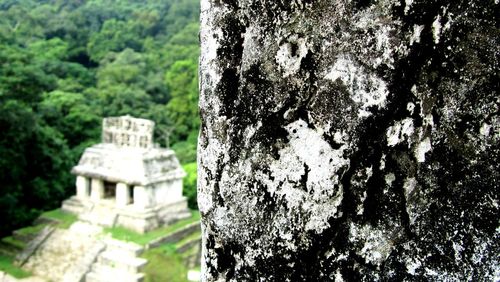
[62,116,190,233]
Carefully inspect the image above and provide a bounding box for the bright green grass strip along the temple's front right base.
[104,211,200,245]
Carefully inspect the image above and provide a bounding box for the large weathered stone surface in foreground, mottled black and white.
[198,0,500,281]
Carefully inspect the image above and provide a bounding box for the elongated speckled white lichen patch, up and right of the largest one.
[324,56,389,117]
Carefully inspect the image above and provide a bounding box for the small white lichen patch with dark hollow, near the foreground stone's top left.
[275,38,308,77]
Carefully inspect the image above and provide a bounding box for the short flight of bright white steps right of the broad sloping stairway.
[85,239,147,282]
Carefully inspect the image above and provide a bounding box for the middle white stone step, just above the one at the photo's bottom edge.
[97,250,148,273]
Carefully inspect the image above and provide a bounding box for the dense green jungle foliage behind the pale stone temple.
[0,0,199,235]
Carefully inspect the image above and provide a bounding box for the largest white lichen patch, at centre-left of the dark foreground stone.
[268,119,349,233]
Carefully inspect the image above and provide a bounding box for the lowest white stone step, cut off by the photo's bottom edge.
[85,265,144,282]
